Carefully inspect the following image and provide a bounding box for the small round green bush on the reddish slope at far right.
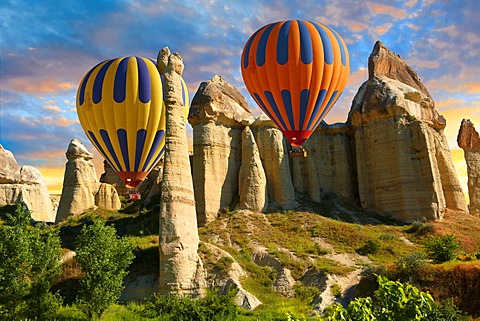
[425,233,461,263]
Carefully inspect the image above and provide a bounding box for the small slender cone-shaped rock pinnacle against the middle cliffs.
[238,126,268,212]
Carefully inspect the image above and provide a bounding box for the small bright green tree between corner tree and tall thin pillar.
[75,222,134,320]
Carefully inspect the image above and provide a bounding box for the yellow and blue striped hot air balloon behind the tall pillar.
[77,57,167,188]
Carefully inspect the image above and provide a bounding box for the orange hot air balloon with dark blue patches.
[241,20,350,155]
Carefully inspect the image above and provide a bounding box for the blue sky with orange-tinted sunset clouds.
[0,0,480,193]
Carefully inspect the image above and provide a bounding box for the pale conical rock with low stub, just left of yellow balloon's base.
[56,138,121,222]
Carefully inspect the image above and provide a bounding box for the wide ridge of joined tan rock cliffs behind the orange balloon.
[189,42,467,222]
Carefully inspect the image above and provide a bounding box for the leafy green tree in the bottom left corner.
[0,205,62,320]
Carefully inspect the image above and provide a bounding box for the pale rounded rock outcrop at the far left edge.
[0,145,55,222]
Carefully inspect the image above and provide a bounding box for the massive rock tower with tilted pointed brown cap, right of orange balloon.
[348,42,466,222]
